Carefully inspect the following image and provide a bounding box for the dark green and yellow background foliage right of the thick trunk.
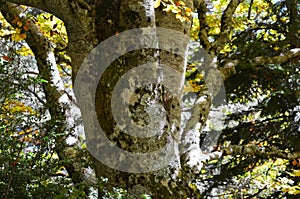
[187,1,300,198]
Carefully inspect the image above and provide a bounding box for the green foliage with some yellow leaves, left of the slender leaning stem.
[0,22,88,198]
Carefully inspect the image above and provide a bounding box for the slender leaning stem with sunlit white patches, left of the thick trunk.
[2,3,90,190]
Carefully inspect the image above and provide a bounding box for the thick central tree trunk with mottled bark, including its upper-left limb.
[0,0,213,198]
